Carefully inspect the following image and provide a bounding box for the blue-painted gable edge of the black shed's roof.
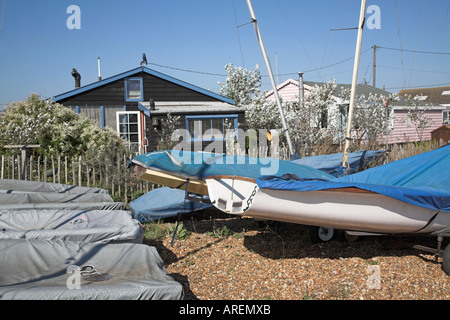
[52,67,234,104]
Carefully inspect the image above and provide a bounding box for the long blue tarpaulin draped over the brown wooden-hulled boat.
[131,150,333,180]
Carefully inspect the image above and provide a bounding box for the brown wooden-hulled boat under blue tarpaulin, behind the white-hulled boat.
[129,150,333,195]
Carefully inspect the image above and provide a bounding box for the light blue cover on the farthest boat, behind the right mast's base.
[292,150,384,177]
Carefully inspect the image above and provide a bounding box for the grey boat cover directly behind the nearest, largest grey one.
[0,210,143,243]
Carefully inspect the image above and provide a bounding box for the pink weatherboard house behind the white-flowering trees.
[266,77,444,143]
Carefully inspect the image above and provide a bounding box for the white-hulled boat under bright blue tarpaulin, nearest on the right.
[206,145,450,234]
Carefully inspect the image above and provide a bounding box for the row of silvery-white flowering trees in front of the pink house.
[221,64,400,154]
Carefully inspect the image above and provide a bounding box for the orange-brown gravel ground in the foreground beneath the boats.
[145,212,450,300]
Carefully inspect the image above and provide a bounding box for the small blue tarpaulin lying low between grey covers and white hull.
[130,187,211,222]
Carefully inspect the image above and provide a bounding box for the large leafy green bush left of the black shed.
[0,94,125,156]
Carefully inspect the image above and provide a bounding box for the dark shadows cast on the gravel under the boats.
[144,209,449,300]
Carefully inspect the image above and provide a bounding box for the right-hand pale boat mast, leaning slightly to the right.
[342,0,366,168]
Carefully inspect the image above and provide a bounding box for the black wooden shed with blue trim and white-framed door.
[52,66,245,153]
